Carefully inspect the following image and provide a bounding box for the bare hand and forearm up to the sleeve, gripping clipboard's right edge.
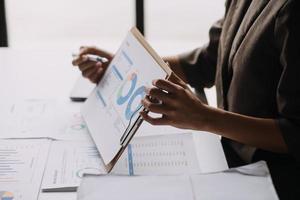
[141,71,287,153]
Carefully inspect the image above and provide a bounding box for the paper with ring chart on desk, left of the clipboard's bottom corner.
[42,141,105,192]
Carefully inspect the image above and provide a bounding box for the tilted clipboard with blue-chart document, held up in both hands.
[81,28,171,172]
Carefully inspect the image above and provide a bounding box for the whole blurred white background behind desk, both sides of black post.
[0,0,225,55]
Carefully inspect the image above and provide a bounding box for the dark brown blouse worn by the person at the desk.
[180,0,300,170]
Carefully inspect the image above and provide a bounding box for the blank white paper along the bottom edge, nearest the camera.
[77,162,278,200]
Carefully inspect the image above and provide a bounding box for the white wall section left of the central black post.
[6,0,134,48]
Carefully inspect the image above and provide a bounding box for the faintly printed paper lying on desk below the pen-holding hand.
[0,99,90,140]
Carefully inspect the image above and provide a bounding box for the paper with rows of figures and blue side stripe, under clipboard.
[112,134,201,175]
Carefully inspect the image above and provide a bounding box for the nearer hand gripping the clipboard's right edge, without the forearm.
[141,73,209,130]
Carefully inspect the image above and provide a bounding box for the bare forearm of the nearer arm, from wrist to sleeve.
[206,108,287,153]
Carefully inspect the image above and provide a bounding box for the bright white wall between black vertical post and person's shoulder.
[146,0,225,53]
